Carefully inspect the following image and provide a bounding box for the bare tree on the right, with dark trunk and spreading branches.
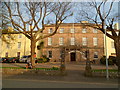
[78,0,120,70]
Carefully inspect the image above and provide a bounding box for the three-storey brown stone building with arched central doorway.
[42,23,104,62]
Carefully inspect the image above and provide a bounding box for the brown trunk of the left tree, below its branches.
[31,39,36,67]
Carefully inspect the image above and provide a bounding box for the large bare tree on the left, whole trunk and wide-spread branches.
[4,2,72,66]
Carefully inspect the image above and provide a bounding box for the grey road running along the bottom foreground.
[2,79,118,88]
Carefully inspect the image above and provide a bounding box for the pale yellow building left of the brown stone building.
[1,33,30,57]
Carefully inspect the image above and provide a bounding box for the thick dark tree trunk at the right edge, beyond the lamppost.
[114,37,120,75]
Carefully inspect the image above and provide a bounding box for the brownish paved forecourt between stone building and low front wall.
[2,62,117,70]
